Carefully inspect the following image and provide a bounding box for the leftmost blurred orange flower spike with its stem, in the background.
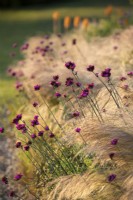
[52,11,60,33]
